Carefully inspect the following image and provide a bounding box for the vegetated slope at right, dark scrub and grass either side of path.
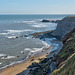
[51,29,75,75]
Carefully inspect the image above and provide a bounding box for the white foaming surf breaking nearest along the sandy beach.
[1,38,58,69]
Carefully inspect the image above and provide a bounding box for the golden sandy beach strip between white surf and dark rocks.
[0,31,62,75]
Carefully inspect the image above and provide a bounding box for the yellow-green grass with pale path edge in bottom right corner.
[51,54,75,75]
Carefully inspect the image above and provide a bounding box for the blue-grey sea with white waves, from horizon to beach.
[0,14,73,69]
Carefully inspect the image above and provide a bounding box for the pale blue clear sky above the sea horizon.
[0,0,75,14]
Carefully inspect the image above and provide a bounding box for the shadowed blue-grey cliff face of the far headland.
[52,16,75,38]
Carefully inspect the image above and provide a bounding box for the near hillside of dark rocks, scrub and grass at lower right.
[29,28,75,75]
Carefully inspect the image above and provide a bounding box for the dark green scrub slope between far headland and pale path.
[58,29,75,58]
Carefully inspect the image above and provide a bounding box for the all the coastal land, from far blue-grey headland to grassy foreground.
[18,16,75,75]
